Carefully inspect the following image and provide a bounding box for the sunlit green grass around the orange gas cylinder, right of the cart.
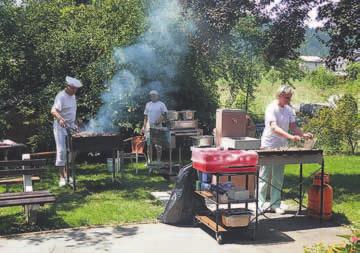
[284,156,360,226]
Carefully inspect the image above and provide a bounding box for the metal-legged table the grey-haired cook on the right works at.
[256,148,324,221]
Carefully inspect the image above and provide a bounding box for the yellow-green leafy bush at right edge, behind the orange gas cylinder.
[305,94,360,154]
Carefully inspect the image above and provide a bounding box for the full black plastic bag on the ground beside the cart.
[159,164,207,225]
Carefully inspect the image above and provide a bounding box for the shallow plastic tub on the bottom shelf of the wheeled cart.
[221,209,251,227]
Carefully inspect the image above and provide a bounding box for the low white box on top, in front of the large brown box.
[220,137,261,150]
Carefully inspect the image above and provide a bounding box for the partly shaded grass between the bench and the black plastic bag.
[0,164,172,234]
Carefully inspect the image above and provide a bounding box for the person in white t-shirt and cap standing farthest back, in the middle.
[141,90,168,163]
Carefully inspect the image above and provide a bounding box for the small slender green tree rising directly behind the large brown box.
[218,16,264,111]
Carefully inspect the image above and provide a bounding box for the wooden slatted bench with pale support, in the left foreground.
[0,159,55,223]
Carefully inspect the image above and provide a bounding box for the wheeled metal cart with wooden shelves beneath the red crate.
[195,166,259,244]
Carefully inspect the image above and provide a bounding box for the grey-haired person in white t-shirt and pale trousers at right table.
[259,85,313,214]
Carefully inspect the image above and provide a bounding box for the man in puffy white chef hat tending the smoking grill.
[51,76,82,187]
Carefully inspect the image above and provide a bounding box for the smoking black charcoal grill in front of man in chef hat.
[66,131,124,191]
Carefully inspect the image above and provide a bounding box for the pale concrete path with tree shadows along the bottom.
[0,215,348,253]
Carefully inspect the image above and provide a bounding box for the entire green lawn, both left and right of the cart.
[0,156,360,234]
